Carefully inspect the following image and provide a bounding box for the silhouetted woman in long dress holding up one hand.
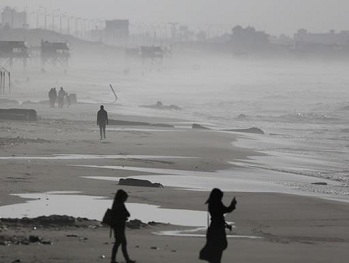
[199,188,237,263]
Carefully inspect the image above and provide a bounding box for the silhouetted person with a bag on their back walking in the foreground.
[111,189,136,263]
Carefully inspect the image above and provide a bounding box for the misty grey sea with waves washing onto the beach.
[98,57,349,199]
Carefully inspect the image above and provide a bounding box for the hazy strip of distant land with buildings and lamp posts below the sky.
[0,4,349,59]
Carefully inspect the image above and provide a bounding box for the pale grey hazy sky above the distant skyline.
[0,0,349,35]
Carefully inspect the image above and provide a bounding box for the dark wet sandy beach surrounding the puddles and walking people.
[0,102,349,263]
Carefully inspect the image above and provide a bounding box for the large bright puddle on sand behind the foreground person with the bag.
[0,192,207,227]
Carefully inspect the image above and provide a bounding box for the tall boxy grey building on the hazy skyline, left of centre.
[105,19,130,44]
